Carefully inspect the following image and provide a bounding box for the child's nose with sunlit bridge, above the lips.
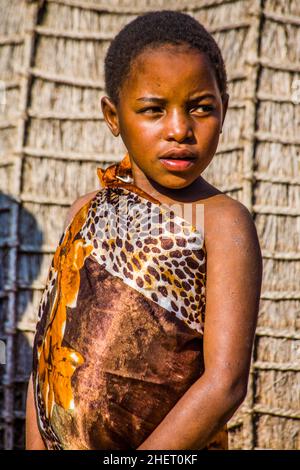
[165,110,193,142]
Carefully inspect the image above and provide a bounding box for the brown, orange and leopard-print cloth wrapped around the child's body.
[33,154,228,450]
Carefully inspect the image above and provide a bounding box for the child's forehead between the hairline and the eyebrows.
[122,45,218,96]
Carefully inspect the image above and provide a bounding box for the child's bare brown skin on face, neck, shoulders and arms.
[27,45,262,450]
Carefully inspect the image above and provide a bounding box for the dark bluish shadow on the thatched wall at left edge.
[0,192,43,449]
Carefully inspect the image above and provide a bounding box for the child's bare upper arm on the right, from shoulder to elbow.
[203,201,262,396]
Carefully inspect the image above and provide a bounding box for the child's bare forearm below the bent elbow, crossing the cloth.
[138,374,244,450]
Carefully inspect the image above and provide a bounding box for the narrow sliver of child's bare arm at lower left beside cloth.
[26,375,46,450]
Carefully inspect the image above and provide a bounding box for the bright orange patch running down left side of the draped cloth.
[38,203,93,418]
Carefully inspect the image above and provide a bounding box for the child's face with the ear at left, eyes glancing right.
[102,45,227,189]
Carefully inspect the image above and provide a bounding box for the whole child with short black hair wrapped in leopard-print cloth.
[27,10,262,449]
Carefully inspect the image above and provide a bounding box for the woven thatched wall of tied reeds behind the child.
[0,0,300,449]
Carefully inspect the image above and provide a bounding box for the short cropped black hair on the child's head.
[104,10,227,105]
